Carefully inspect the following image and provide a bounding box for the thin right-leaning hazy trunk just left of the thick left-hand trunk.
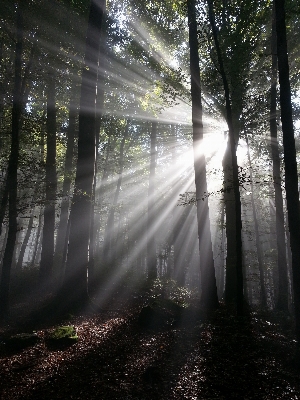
[54,88,77,285]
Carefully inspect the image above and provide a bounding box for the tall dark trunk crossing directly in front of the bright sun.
[188,0,218,309]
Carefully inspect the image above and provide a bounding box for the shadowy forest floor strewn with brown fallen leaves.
[0,292,300,400]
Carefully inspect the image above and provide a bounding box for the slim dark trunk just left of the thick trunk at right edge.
[270,5,288,312]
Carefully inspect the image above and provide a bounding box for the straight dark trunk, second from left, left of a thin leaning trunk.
[40,71,57,288]
